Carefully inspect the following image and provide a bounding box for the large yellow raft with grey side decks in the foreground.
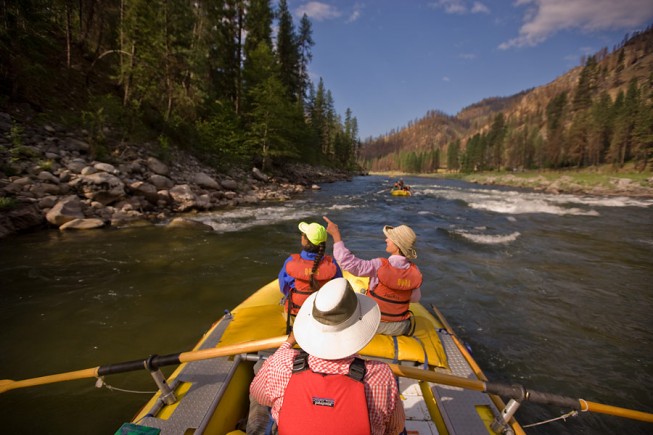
[126,273,524,435]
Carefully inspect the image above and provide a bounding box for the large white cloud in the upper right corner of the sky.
[499,0,653,50]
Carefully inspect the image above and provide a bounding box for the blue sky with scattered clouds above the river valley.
[288,0,653,139]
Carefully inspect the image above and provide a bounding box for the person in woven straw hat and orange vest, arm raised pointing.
[323,216,422,335]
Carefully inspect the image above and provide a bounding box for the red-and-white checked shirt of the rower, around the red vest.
[249,342,406,435]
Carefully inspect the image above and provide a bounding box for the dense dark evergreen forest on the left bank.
[0,0,358,174]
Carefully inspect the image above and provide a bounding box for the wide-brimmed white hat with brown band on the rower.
[293,278,381,360]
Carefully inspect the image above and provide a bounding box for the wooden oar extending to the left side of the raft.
[0,335,288,393]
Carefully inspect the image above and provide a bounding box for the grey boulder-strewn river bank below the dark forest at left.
[0,112,355,238]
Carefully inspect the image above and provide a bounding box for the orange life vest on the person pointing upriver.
[369,258,422,322]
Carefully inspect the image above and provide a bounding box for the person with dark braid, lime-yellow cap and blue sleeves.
[279,222,342,320]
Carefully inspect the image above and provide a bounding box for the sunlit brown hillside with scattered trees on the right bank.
[359,28,653,173]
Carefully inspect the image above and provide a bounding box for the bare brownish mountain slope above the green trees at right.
[359,27,653,172]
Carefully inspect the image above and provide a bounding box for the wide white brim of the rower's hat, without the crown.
[293,292,381,360]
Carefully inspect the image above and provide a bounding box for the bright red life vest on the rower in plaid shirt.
[277,352,371,435]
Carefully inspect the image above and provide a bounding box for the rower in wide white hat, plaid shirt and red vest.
[247,278,406,435]
